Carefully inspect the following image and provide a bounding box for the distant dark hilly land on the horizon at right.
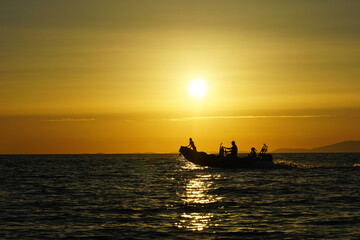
[272,141,360,153]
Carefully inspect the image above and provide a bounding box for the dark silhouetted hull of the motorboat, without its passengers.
[179,146,275,168]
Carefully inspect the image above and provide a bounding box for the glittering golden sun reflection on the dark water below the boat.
[175,162,222,231]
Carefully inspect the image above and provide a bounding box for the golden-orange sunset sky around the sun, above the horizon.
[0,0,360,154]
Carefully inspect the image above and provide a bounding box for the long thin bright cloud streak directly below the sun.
[169,115,333,121]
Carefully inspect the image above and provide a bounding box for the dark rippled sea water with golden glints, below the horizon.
[0,153,360,239]
